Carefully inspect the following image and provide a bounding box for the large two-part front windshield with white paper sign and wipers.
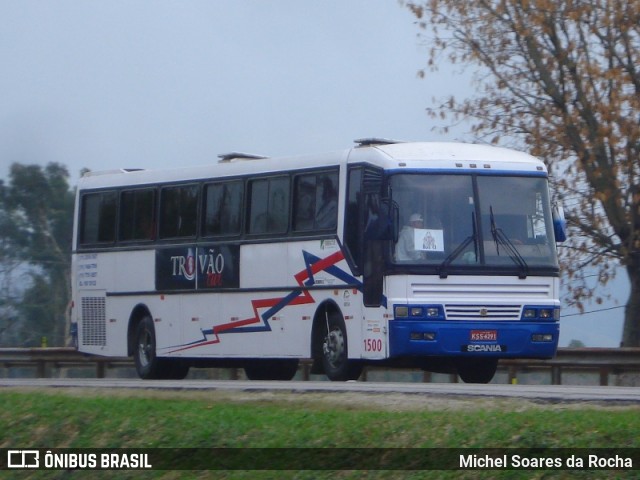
[390,174,558,275]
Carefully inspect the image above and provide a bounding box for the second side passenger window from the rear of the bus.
[119,189,155,241]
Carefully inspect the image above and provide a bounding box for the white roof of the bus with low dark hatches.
[79,139,547,189]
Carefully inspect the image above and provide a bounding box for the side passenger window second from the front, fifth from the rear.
[249,177,289,234]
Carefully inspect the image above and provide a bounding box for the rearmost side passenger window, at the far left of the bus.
[80,192,117,245]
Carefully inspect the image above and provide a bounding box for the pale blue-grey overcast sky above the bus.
[0,0,626,346]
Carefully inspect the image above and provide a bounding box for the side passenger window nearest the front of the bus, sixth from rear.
[293,173,338,232]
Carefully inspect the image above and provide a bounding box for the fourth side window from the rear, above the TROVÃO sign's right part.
[203,181,244,236]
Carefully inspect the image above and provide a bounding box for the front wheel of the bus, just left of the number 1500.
[320,312,363,382]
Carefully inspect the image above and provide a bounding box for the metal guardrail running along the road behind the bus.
[0,347,640,386]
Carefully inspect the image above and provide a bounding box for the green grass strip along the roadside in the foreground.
[0,389,640,479]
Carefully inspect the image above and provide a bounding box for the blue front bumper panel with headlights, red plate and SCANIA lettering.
[389,320,560,358]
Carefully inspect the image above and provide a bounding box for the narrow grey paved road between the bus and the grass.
[0,378,640,404]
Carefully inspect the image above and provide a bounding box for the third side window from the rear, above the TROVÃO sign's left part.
[160,185,198,238]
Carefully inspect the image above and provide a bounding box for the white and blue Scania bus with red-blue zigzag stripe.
[72,139,564,382]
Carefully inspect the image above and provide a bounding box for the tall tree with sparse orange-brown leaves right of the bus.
[405,0,640,347]
